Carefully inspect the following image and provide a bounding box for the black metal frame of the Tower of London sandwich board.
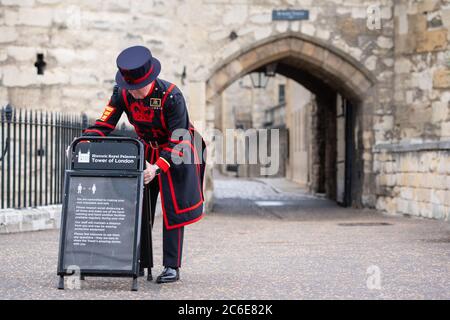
[57,136,145,291]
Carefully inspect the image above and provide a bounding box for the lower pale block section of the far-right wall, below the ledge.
[375,145,450,220]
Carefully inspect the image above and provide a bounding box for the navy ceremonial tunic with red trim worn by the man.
[83,79,206,229]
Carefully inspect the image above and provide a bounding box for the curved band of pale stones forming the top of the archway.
[206,32,376,102]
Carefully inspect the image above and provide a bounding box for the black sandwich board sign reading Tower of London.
[57,137,145,291]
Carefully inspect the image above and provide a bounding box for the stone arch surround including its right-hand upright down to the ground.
[206,32,377,207]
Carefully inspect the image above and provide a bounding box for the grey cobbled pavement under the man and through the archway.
[0,177,450,299]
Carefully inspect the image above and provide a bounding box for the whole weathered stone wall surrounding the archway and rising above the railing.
[0,0,450,217]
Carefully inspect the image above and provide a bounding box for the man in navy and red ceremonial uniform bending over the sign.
[83,46,206,283]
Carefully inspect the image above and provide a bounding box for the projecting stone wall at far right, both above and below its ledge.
[374,0,450,220]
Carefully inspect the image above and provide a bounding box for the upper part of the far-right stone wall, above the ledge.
[390,0,450,142]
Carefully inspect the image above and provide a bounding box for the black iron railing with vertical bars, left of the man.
[0,105,133,209]
